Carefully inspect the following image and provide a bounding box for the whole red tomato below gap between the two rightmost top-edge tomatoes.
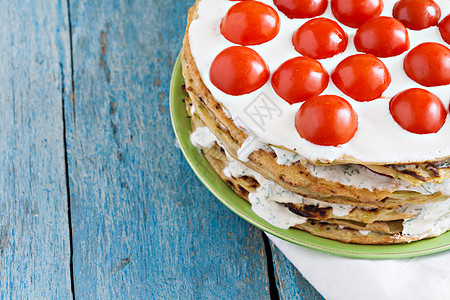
[354,17,409,57]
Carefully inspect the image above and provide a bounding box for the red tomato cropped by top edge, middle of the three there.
[331,0,383,28]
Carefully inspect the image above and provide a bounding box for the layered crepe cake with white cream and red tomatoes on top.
[182,0,450,244]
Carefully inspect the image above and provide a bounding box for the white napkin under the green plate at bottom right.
[268,234,450,300]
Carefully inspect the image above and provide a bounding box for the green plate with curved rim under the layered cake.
[170,52,450,259]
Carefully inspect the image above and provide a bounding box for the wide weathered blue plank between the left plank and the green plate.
[66,0,269,299]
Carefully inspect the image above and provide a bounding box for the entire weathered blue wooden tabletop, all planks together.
[0,0,321,299]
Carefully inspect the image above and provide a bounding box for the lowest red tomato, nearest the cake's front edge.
[295,95,358,146]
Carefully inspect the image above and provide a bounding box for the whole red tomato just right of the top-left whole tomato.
[292,18,348,59]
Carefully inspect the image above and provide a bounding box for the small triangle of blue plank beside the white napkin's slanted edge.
[270,242,324,300]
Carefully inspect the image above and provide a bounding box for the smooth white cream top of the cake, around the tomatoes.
[189,0,450,163]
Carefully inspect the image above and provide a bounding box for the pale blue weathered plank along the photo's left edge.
[0,1,71,299]
